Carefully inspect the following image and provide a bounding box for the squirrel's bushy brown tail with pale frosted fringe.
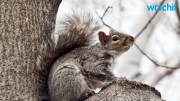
[36,13,101,101]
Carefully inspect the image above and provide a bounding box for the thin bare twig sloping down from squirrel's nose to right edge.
[134,43,180,69]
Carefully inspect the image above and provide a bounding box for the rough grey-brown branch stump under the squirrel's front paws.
[85,78,163,101]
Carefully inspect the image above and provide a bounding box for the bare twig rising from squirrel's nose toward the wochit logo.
[135,0,165,39]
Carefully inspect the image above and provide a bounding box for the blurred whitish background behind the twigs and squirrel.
[57,0,180,101]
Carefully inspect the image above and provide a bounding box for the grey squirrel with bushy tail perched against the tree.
[36,13,134,101]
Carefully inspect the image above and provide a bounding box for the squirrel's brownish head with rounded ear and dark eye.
[98,30,134,54]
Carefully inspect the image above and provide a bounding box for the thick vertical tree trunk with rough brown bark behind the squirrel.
[0,0,61,101]
